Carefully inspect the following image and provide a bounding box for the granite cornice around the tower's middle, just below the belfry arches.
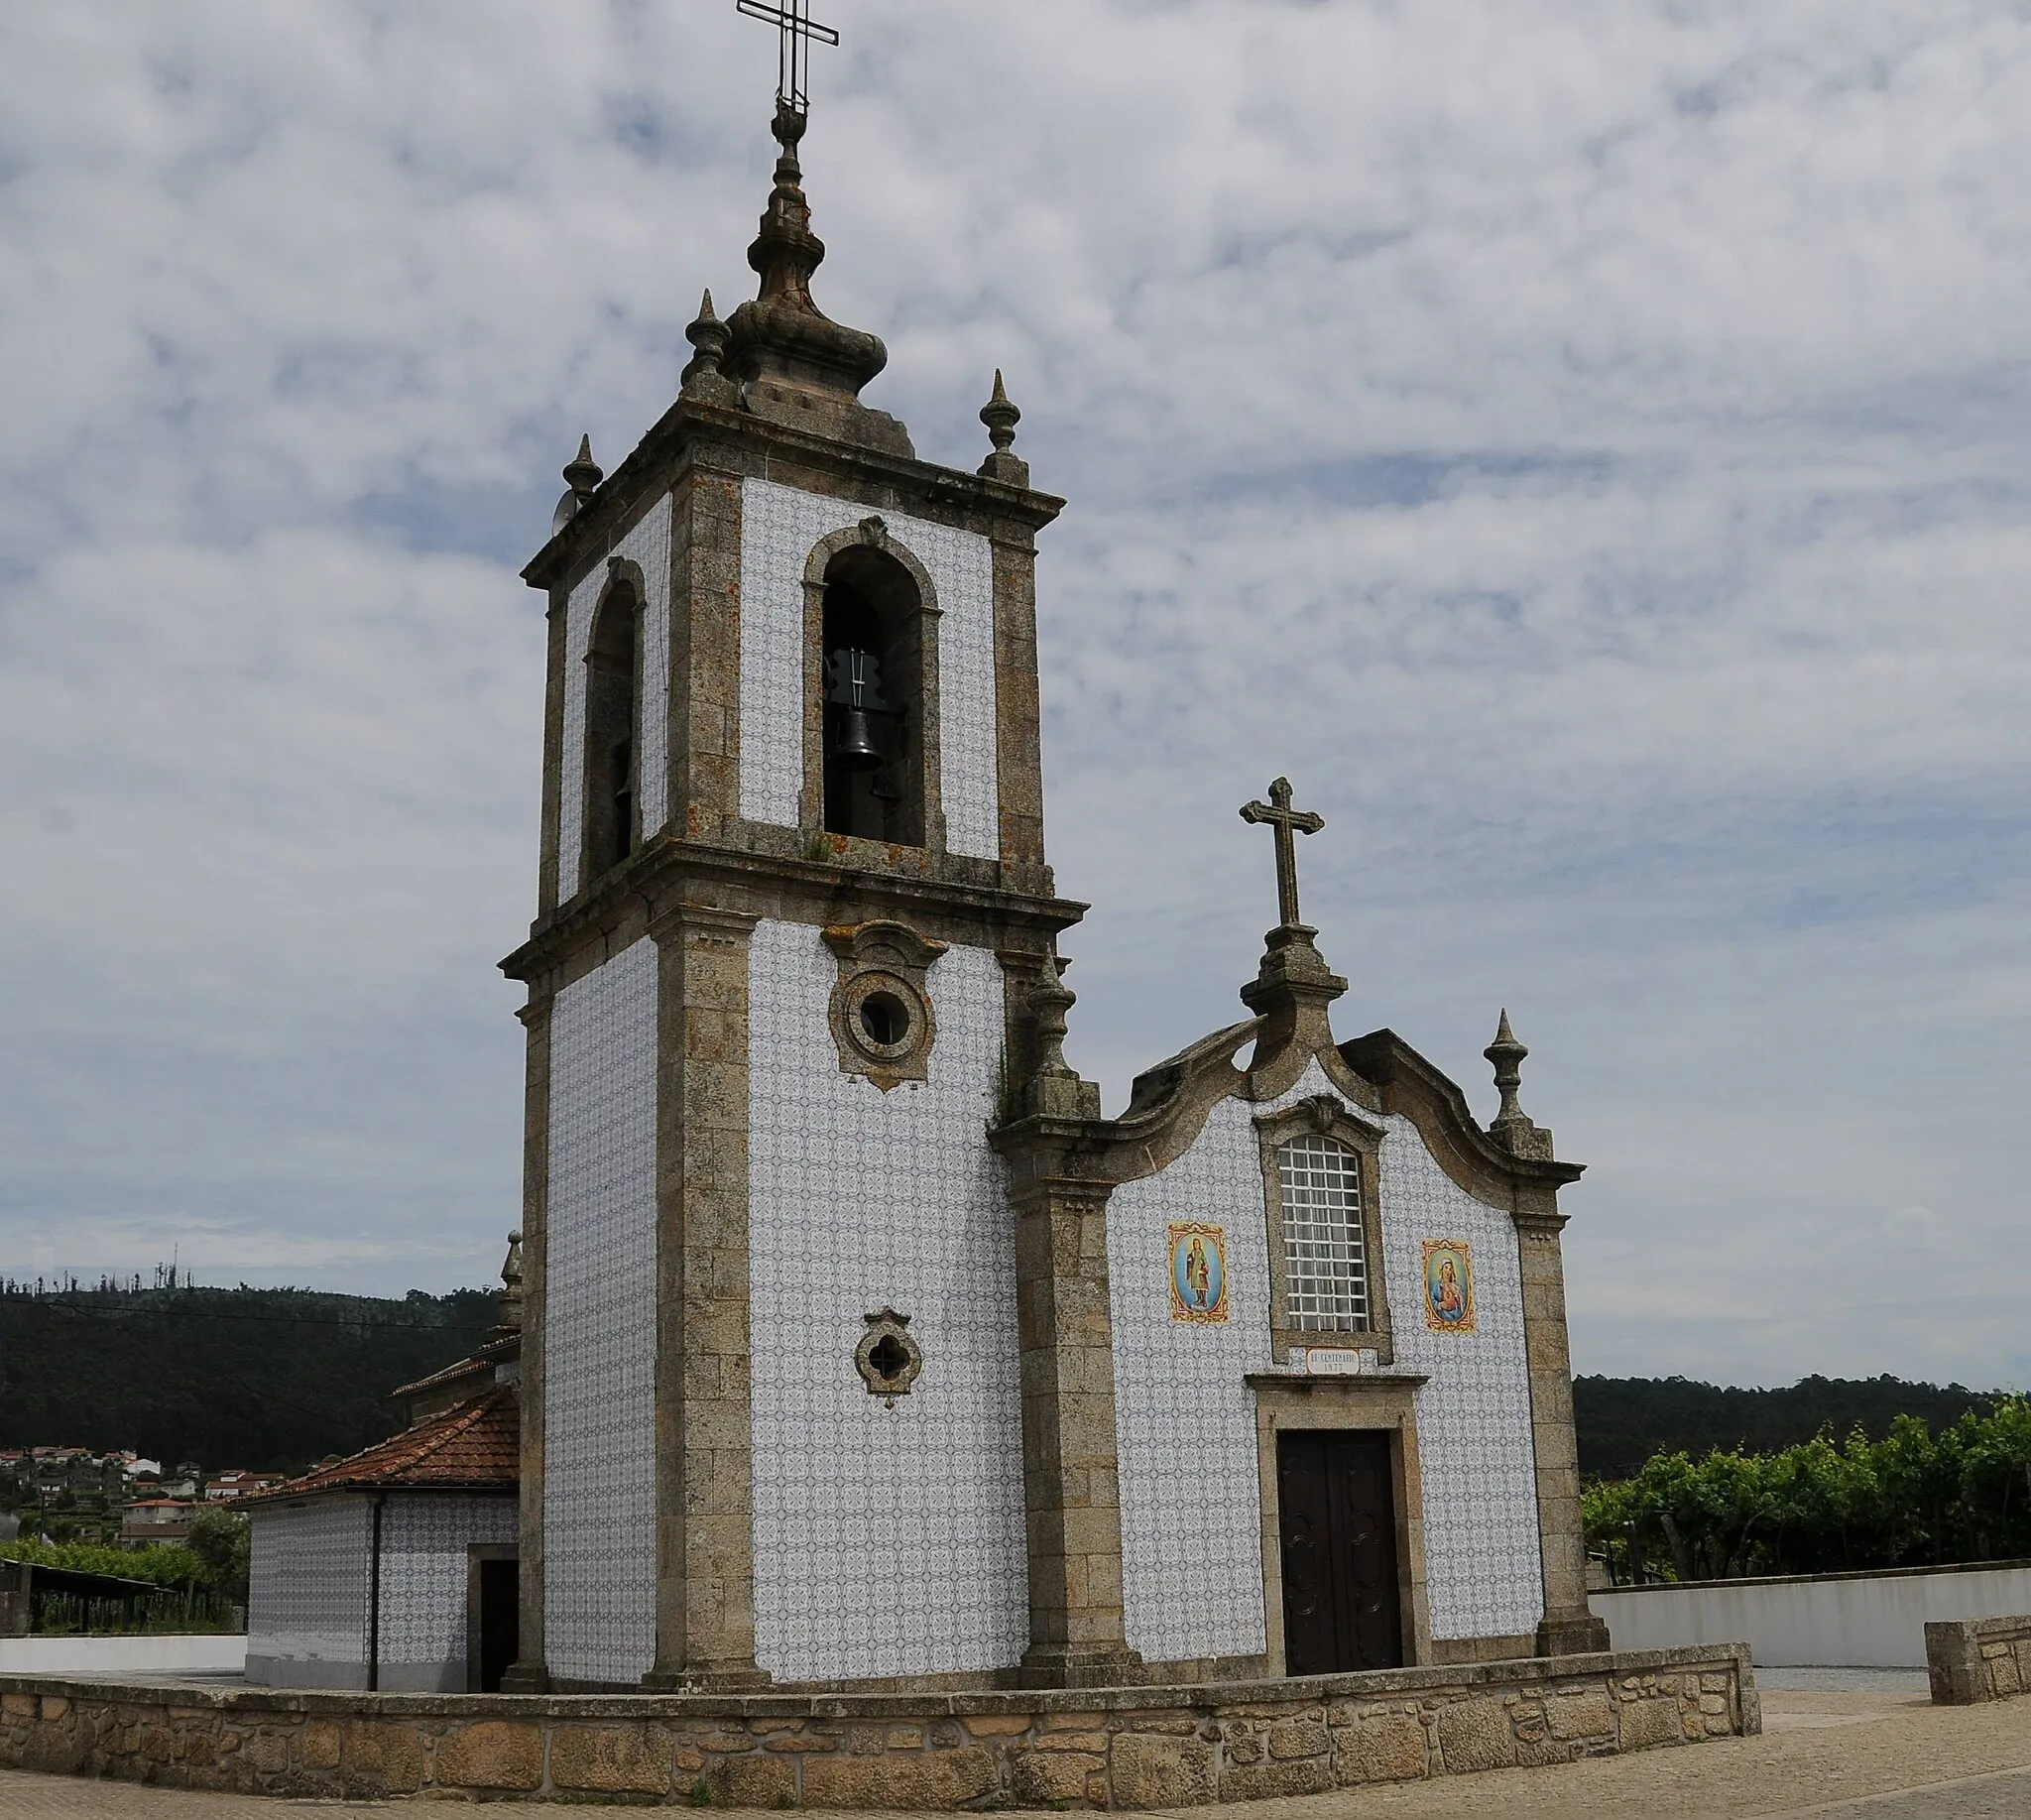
[500,833,1087,991]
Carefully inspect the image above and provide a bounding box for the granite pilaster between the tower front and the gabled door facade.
[1016,1176,1141,1686]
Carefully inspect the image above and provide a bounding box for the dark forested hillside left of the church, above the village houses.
[0,1287,500,1471]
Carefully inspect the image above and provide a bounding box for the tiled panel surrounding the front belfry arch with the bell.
[742,479,1002,859]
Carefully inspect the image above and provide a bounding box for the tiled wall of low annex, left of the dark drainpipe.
[248,1497,374,1661]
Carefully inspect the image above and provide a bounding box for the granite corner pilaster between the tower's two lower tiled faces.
[646,904,768,1688]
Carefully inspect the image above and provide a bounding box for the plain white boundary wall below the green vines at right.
[1589,1562,2031,1667]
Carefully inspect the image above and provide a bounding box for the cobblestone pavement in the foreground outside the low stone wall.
[0,1688,2031,1820]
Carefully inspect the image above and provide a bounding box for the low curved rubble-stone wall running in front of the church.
[0,1645,1761,1808]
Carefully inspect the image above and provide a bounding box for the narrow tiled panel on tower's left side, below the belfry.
[542,940,657,1682]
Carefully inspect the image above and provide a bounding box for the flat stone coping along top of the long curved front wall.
[0,1643,1752,1721]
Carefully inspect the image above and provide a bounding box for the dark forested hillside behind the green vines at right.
[1572,1378,1998,1479]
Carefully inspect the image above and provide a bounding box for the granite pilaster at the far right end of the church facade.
[1515,1194,1609,1655]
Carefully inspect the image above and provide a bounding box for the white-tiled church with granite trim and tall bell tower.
[256,95,1607,1692]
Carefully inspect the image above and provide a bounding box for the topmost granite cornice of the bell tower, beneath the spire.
[522,398,1064,589]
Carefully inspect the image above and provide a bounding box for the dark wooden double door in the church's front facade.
[1275,1428,1403,1674]
